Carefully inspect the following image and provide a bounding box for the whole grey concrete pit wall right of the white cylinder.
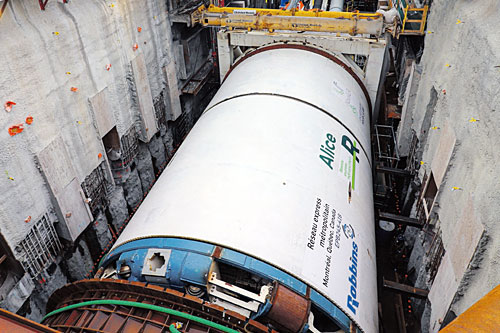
[402,0,500,332]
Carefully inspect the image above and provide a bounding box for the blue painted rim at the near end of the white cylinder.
[101,238,350,331]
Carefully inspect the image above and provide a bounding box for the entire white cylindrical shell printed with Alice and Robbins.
[114,49,378,332]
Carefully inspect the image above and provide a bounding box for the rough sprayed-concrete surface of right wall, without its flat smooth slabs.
[404,0,500,331]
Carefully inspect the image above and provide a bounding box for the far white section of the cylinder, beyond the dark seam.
[208,49,370,156]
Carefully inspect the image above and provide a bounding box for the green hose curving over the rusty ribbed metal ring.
[42,299,239,333]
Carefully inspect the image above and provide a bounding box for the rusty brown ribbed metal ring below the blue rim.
[44,279,276,333]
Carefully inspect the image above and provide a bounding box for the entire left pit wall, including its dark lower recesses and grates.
[0,0,210,321]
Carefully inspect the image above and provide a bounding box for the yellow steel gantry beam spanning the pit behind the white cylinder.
[192,5,383,36]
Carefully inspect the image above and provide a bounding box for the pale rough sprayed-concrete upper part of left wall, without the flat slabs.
[0,1,173,253]
